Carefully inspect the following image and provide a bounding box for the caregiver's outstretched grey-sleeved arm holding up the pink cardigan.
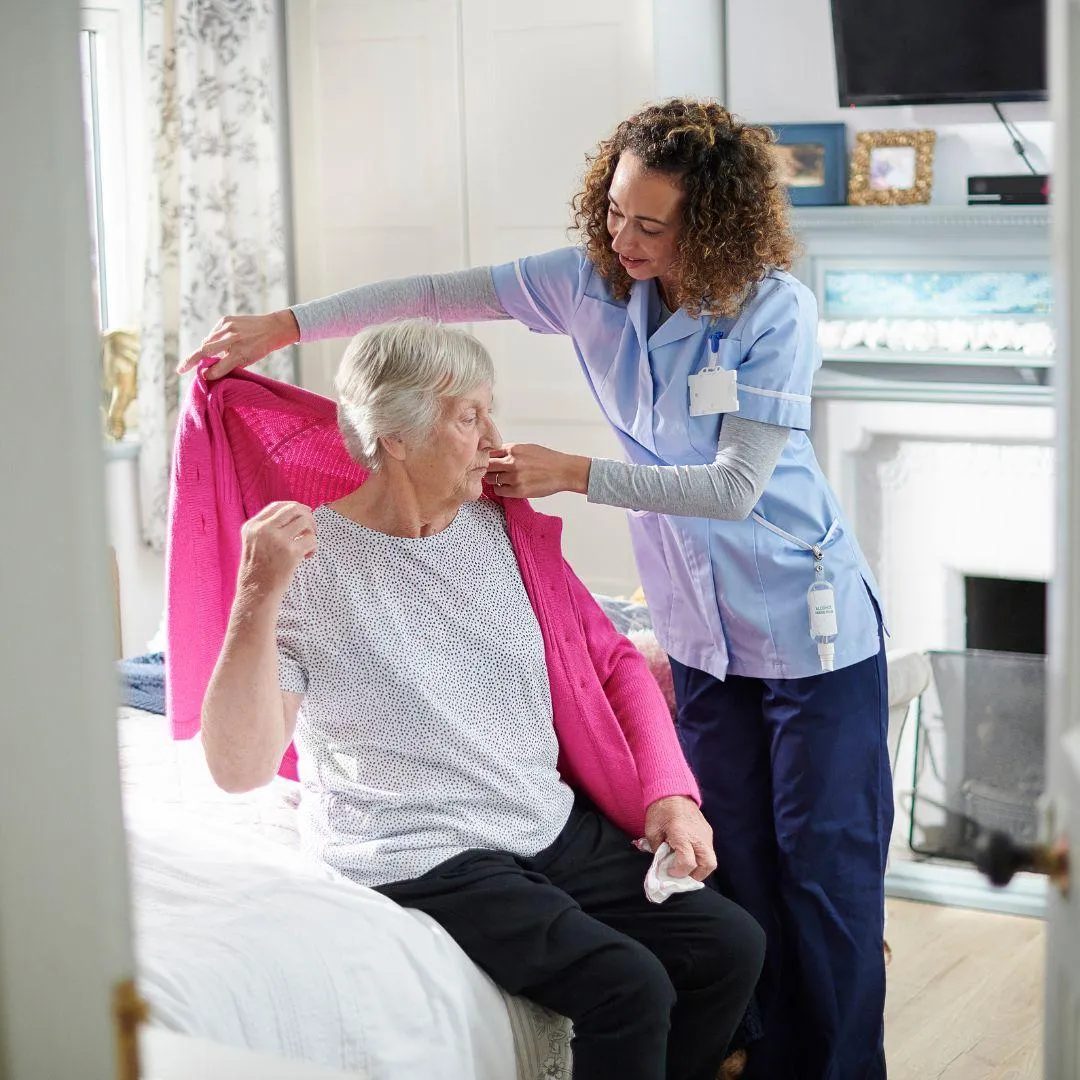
[177,267,510,379]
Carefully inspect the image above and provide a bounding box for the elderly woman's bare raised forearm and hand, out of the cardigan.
[202,502,315,793]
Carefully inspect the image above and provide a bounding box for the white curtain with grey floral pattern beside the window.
[138,0,295,550]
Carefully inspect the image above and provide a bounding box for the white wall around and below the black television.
[727,0,1051,204]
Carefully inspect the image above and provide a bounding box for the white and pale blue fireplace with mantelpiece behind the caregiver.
[796,207,1054,914]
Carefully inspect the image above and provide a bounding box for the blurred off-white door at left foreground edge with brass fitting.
[0,0,139,1080]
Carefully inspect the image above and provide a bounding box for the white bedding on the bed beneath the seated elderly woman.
[120,710,570,1080]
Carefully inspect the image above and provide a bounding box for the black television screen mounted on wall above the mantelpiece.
[832,0,1047,105]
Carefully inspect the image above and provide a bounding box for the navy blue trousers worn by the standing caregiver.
[672,630,893,1080]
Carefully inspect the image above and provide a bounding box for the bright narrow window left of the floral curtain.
[79,0,146,330]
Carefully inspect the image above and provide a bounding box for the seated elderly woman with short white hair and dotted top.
[203,321,764,1080]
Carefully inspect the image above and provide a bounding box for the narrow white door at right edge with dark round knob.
[1045,0,1080,1080]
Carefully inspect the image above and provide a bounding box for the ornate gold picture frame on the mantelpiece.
[848,130,937,206]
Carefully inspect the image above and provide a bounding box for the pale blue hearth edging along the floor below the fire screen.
[885,860,1047,919]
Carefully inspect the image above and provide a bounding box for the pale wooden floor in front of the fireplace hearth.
[886,900,1045,1080]
